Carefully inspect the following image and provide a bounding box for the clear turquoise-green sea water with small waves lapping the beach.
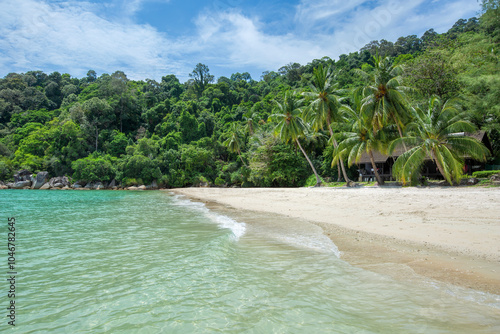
[0,190,500,333]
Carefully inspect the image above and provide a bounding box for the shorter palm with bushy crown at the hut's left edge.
[332,93,389,185]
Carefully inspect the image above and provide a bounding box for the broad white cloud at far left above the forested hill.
[0,0,183,79]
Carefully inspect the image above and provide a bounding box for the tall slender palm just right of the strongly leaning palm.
[302,65,352,186]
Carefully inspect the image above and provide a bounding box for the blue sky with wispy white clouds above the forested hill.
[0,0,480,82]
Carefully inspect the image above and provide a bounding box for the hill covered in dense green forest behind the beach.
[0,1,500,187]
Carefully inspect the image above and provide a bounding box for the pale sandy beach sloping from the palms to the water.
[174,187,500,295]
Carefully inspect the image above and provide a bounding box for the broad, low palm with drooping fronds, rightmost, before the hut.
[389,97,489,185]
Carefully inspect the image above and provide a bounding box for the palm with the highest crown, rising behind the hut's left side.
[356,55,410,151]
